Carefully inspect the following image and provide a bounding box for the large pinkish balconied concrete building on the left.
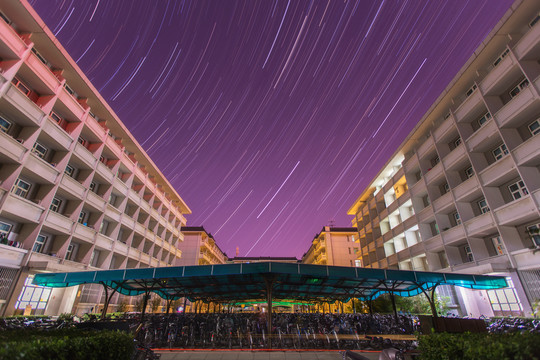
[0,0,190,315]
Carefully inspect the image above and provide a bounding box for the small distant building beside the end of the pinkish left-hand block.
[176,226,228,265]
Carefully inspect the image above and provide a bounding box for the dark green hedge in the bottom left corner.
[0,329,134,360]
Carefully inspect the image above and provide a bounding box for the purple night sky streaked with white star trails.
[30,0,512,257]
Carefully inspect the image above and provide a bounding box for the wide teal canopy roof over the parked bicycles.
[33,262,507,302]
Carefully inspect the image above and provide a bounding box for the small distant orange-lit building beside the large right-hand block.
[302,226,360,267]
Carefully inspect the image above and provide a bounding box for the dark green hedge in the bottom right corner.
[418,333,540,360]
